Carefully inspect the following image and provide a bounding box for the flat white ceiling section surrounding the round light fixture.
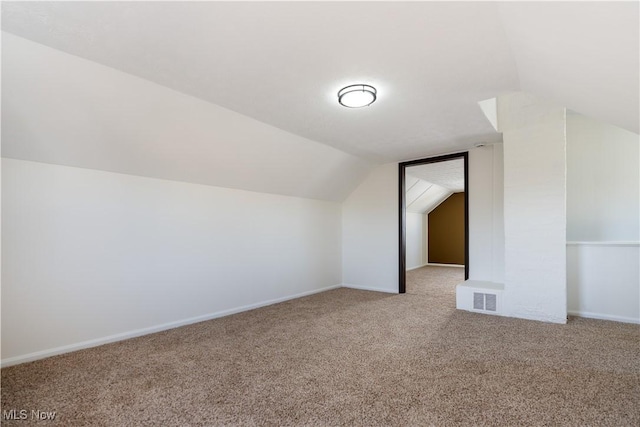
[2,2,519,163]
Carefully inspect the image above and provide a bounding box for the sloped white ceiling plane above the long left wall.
[2,34,371,201]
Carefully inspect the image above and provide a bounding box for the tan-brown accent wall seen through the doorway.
[428,193,465,265]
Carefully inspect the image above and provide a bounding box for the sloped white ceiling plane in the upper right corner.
[500,1,640,133]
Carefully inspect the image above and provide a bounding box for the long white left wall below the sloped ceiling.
[2,159,341,364]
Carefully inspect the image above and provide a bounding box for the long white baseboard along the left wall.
[0,284,342,368]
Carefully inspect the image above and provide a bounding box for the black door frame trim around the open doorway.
[398,151,469,294]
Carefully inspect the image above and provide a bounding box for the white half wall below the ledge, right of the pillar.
[567,242,640,323]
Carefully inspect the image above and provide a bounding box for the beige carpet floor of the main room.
[2,271,640,426]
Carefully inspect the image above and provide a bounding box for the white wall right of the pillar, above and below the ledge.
[567,114,640,323]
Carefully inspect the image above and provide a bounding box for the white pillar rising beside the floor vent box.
[498,93,567,323]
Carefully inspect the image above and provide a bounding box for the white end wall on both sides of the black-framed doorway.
[342,152,504,293]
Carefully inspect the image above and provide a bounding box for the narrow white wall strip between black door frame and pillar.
[469,144,504,283]
